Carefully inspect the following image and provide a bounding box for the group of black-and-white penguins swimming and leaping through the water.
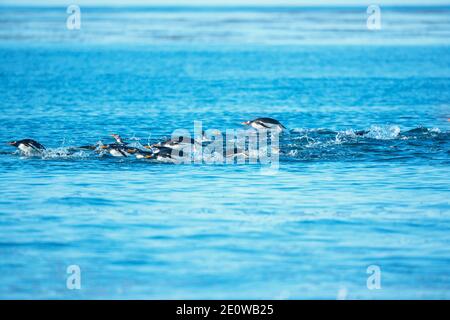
[8,118,286,162]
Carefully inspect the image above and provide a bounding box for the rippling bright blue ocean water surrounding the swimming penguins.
[0,7,450,299]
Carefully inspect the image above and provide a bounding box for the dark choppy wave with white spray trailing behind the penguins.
[281,125,450,160]
